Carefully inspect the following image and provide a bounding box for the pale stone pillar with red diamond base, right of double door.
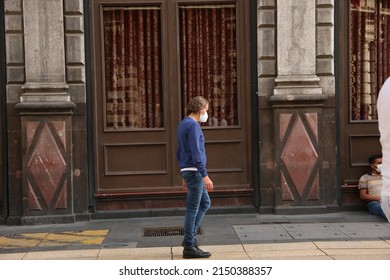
[269,0,327,214]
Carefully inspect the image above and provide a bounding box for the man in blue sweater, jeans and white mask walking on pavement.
[177,96,214,258]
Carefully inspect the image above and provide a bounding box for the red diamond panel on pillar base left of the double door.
[24,119,69,214]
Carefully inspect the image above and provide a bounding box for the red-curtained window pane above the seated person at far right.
[350,0,390,120]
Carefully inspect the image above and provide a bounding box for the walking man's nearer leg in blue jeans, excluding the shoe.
[182,172,203,247]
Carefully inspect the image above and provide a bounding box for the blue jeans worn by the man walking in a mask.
[181,171,211,247]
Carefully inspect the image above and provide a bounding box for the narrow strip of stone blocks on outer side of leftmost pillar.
[4,0,26,223]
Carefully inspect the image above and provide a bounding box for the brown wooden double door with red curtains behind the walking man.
[90,0,253,210]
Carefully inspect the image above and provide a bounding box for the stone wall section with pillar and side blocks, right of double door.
[257,0,337,212]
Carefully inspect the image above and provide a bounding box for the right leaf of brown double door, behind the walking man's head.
[175,1,252,192]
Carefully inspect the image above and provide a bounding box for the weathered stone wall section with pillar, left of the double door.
[4,0,88,223]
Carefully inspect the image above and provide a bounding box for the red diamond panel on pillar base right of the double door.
[279,111,320,204]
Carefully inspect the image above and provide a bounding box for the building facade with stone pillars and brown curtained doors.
[0,0,384,224]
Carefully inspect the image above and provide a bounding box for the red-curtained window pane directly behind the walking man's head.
[179,4,238,126]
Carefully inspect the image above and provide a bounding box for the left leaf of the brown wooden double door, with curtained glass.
[93,0,173,194]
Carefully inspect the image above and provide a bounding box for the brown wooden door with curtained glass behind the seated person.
[336,1,381,186]
